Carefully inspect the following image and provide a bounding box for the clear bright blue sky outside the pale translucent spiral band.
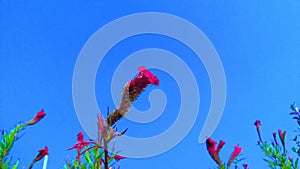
[0,0,300,169]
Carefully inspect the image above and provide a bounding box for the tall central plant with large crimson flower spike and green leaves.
[64,66,159,169]
